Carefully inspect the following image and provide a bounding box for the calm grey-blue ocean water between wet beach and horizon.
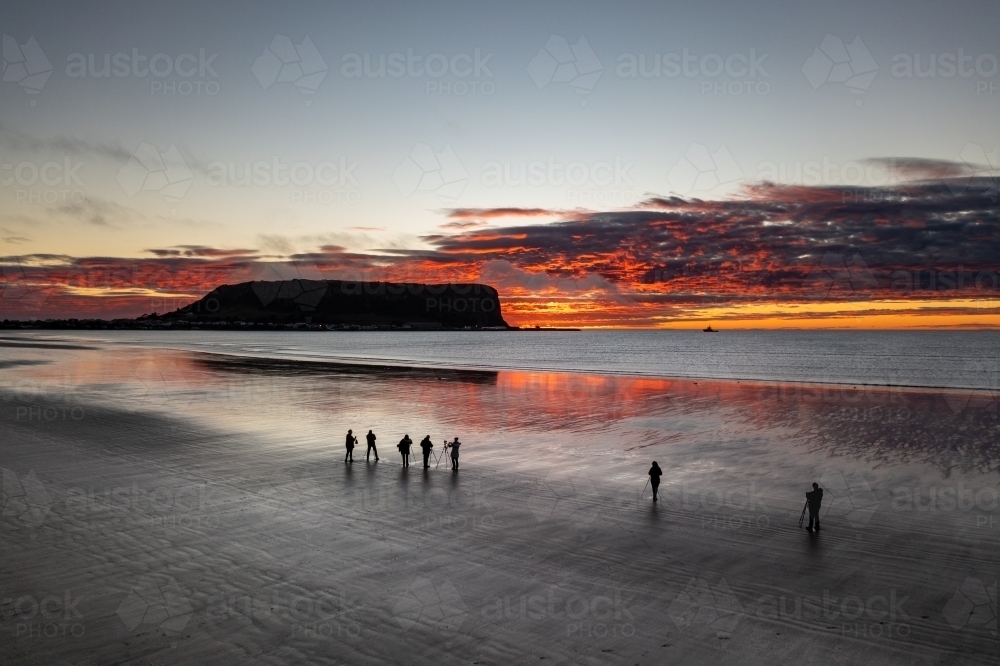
[0,330,1000,392]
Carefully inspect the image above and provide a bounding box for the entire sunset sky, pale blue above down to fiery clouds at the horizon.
[0,0,1000,328]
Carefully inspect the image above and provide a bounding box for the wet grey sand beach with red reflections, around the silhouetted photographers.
[0,336,1000,665]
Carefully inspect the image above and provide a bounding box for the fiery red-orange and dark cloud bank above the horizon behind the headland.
[0,174,1000,328]
